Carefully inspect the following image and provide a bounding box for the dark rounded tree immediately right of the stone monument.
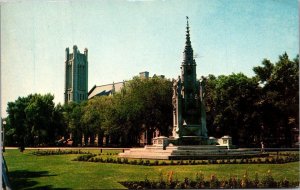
[205,73,260,146]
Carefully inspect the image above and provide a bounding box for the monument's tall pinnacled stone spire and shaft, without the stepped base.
[173,17,207,144]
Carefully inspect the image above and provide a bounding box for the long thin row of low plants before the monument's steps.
[74,154,299,166]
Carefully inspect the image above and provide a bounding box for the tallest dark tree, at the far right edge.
[253,53,299,146]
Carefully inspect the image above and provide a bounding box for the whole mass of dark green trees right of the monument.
[205,53,299,147]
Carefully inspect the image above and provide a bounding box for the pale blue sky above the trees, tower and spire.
[1,0,299,117]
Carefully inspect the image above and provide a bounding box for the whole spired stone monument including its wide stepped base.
[119,17,261,159]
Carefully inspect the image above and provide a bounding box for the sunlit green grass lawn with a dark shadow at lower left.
[4,150,299,189]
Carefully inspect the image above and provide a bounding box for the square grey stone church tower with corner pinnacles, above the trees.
[65,45,88,103]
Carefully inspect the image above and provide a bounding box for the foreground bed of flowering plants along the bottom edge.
[120,171,299,189]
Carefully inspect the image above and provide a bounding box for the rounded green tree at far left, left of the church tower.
[7,94,63,147]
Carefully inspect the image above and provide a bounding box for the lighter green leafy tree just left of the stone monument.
[106,77,172,145]
